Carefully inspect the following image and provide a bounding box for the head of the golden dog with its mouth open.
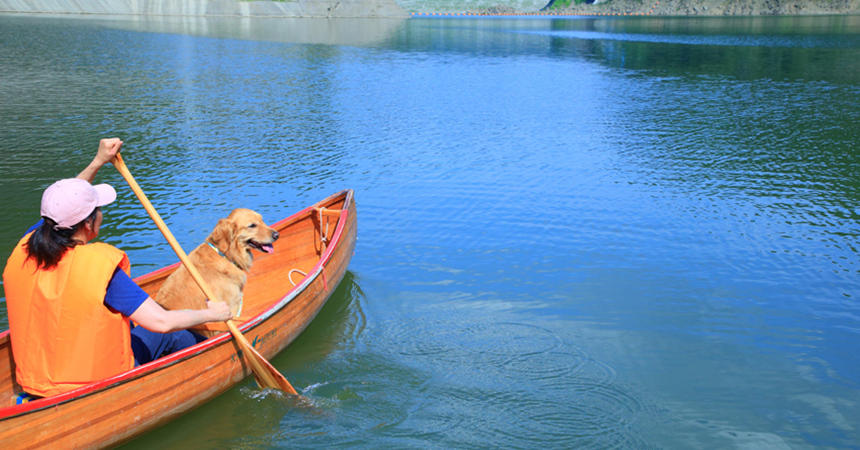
[206,208,278,270]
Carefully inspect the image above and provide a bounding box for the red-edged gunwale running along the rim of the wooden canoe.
[0,189,354,422]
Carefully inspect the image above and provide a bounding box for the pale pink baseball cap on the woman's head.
[42,178,116,228]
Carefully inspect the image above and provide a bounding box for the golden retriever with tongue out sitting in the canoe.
[155,208,278,337]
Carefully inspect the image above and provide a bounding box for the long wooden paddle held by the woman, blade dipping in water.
[112,153,298,395]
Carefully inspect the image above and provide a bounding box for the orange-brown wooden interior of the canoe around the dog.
[0,191,350,408]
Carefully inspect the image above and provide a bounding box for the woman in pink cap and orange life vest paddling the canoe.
[3,138,232,397]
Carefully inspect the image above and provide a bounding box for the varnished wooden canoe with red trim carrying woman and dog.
[0,190,356,448]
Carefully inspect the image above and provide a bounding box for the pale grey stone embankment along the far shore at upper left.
[0,0,409,18]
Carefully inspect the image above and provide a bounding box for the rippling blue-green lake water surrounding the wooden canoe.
[0,15,860,448]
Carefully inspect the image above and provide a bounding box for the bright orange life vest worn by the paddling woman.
[3,234,134,397]
